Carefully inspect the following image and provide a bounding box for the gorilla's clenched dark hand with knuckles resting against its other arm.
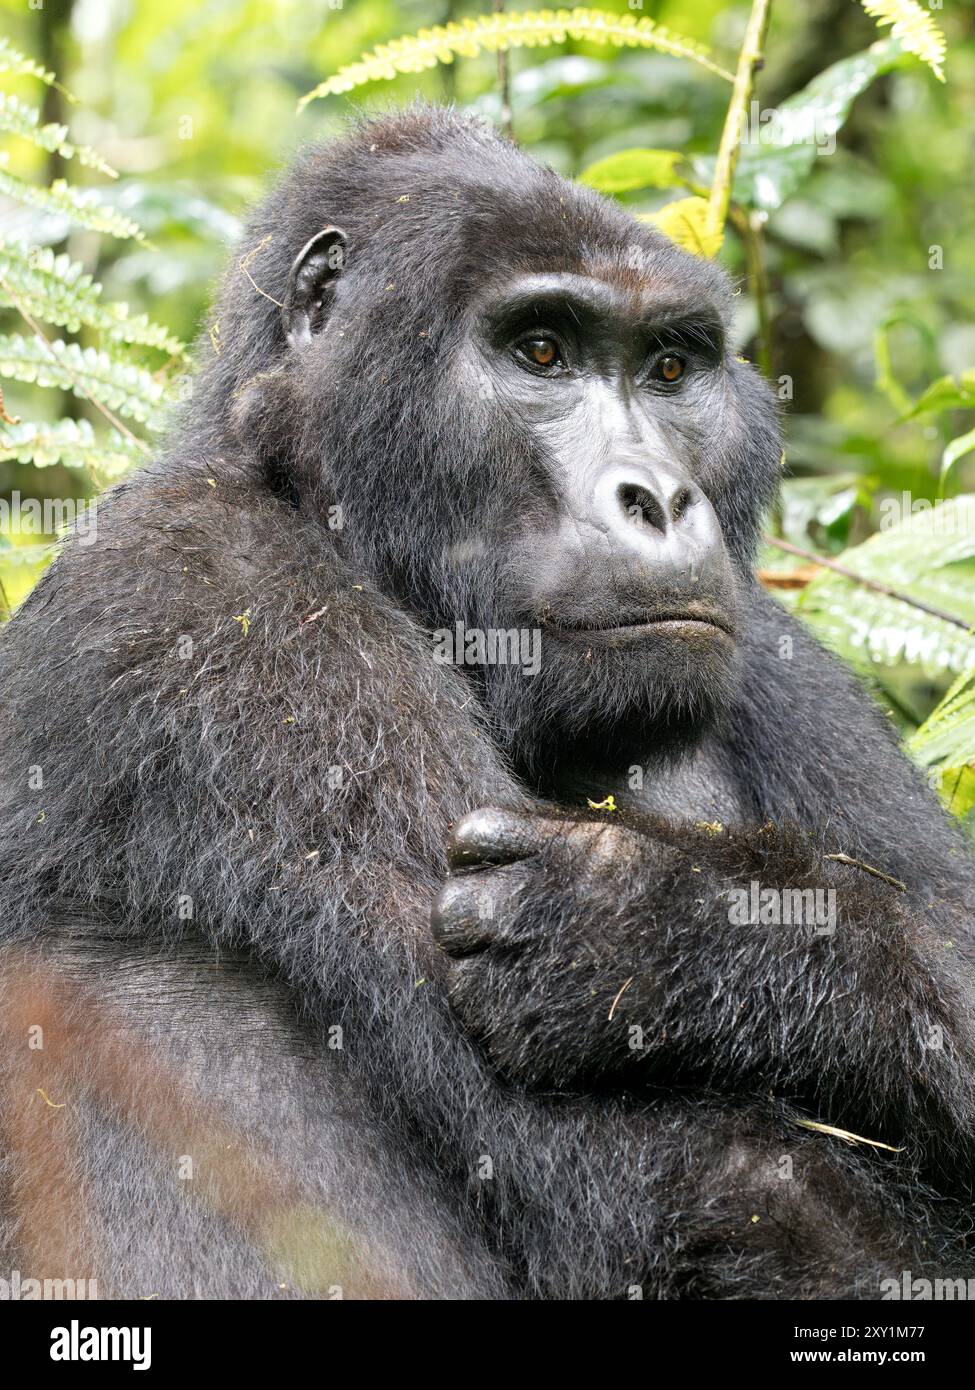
[433,809,664,1087]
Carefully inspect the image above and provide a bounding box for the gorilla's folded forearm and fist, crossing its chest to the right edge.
[434,810,975,1186]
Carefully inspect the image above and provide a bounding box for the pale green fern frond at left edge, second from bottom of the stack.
[0,334,164,428]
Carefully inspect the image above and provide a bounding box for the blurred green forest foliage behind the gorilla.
[0,0,975,823]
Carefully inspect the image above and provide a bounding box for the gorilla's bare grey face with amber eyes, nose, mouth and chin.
[473,272,739,778]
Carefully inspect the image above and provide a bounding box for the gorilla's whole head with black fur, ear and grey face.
[210,111,780,780]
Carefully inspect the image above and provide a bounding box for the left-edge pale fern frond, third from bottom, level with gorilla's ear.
[0,236,186,357]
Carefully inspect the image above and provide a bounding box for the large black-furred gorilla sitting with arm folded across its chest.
[0,108,975,1298]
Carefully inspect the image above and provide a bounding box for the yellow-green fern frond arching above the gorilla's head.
[298,8,734,111]
